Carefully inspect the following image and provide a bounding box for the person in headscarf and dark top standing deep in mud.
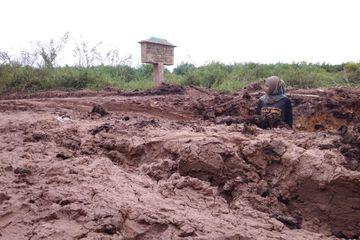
[256,76,293,128]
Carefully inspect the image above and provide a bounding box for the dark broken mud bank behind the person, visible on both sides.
[193,89,360,131]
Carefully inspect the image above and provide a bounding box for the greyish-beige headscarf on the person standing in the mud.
[260,76,286,104]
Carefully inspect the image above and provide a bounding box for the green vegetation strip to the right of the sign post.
[167,62,360,92]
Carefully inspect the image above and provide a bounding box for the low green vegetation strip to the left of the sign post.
[0,65,152,92]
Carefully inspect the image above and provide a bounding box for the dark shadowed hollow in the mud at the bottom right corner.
[288,179,360,239]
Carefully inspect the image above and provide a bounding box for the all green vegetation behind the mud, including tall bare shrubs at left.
[0,33,360,93]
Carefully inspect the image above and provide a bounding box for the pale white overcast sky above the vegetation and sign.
[0,0,360,65]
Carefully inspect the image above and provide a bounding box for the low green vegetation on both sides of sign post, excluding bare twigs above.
[0,63,360,92]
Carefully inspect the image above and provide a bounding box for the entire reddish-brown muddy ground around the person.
[0,86,360,239]
